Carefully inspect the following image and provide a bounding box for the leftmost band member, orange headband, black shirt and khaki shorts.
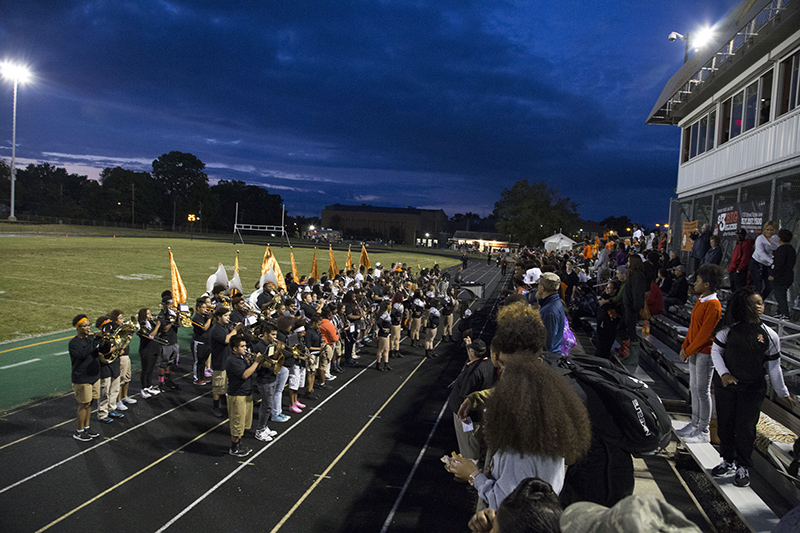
[69,315,100,442]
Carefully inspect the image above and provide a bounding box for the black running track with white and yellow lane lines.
[0,261,510,533]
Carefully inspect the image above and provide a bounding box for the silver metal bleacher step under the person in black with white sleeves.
[672,419,779,533]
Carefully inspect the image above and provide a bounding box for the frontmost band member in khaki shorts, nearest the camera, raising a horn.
[225,335,264,457]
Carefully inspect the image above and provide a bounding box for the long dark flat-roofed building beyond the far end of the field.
[322,204,449,247]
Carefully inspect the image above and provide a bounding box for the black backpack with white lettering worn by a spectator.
[551,356,672,455]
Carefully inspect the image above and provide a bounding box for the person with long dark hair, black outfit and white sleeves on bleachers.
[711,286,795,487]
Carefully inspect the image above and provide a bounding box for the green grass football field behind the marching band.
[0,235,458,342]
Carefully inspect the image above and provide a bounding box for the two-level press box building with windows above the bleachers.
[647,0,800,274]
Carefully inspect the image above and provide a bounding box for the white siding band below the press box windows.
[677,109,800,196]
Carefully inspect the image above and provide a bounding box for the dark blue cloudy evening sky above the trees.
[0,0,739,224]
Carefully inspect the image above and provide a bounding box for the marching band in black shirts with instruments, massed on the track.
[69,263,459,457]
